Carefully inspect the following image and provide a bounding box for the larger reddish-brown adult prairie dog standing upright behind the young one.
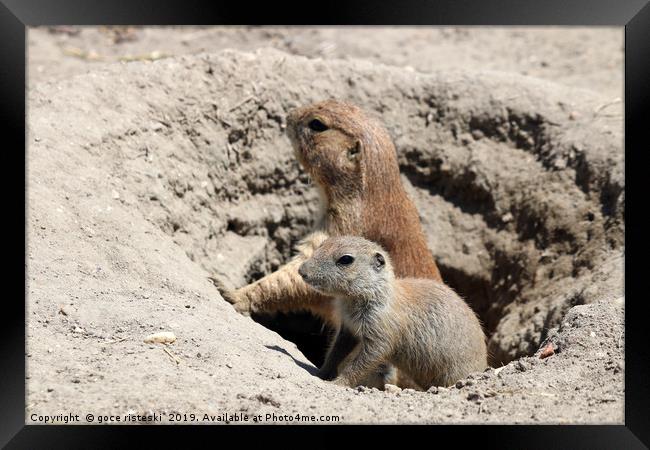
[222,100,441,325]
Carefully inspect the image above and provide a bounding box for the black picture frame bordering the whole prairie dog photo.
[0,0,650,449]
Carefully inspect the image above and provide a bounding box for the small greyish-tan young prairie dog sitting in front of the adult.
[298,236,487,389]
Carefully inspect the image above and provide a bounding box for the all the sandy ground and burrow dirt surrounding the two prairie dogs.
[26,28,625,423]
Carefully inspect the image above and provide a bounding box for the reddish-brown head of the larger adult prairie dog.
[287,100,399,197]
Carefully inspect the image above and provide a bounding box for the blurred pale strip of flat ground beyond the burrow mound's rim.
[28,26,624,98]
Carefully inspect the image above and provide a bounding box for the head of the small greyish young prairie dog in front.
[298,236,394,299]
